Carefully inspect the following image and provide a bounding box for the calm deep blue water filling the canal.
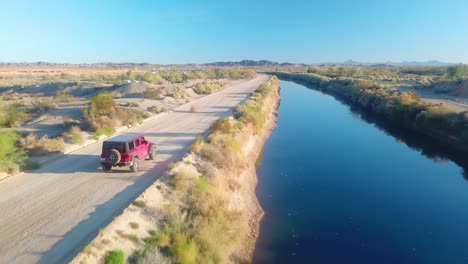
[254,81,468,264]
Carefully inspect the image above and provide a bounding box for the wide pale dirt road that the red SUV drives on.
[0,76,268,264]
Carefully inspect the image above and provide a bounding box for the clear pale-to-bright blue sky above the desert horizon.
[0,0,468,64]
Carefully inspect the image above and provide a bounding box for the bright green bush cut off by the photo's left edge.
[0,132,27,173]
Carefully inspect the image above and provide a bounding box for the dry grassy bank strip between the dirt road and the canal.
[72,76,280,263]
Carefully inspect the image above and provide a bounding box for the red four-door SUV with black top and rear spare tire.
[101,134,156,172]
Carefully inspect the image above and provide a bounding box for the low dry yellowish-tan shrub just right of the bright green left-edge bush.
[19,134,65,155]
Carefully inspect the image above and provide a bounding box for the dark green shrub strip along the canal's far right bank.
[268,72,468,152]
